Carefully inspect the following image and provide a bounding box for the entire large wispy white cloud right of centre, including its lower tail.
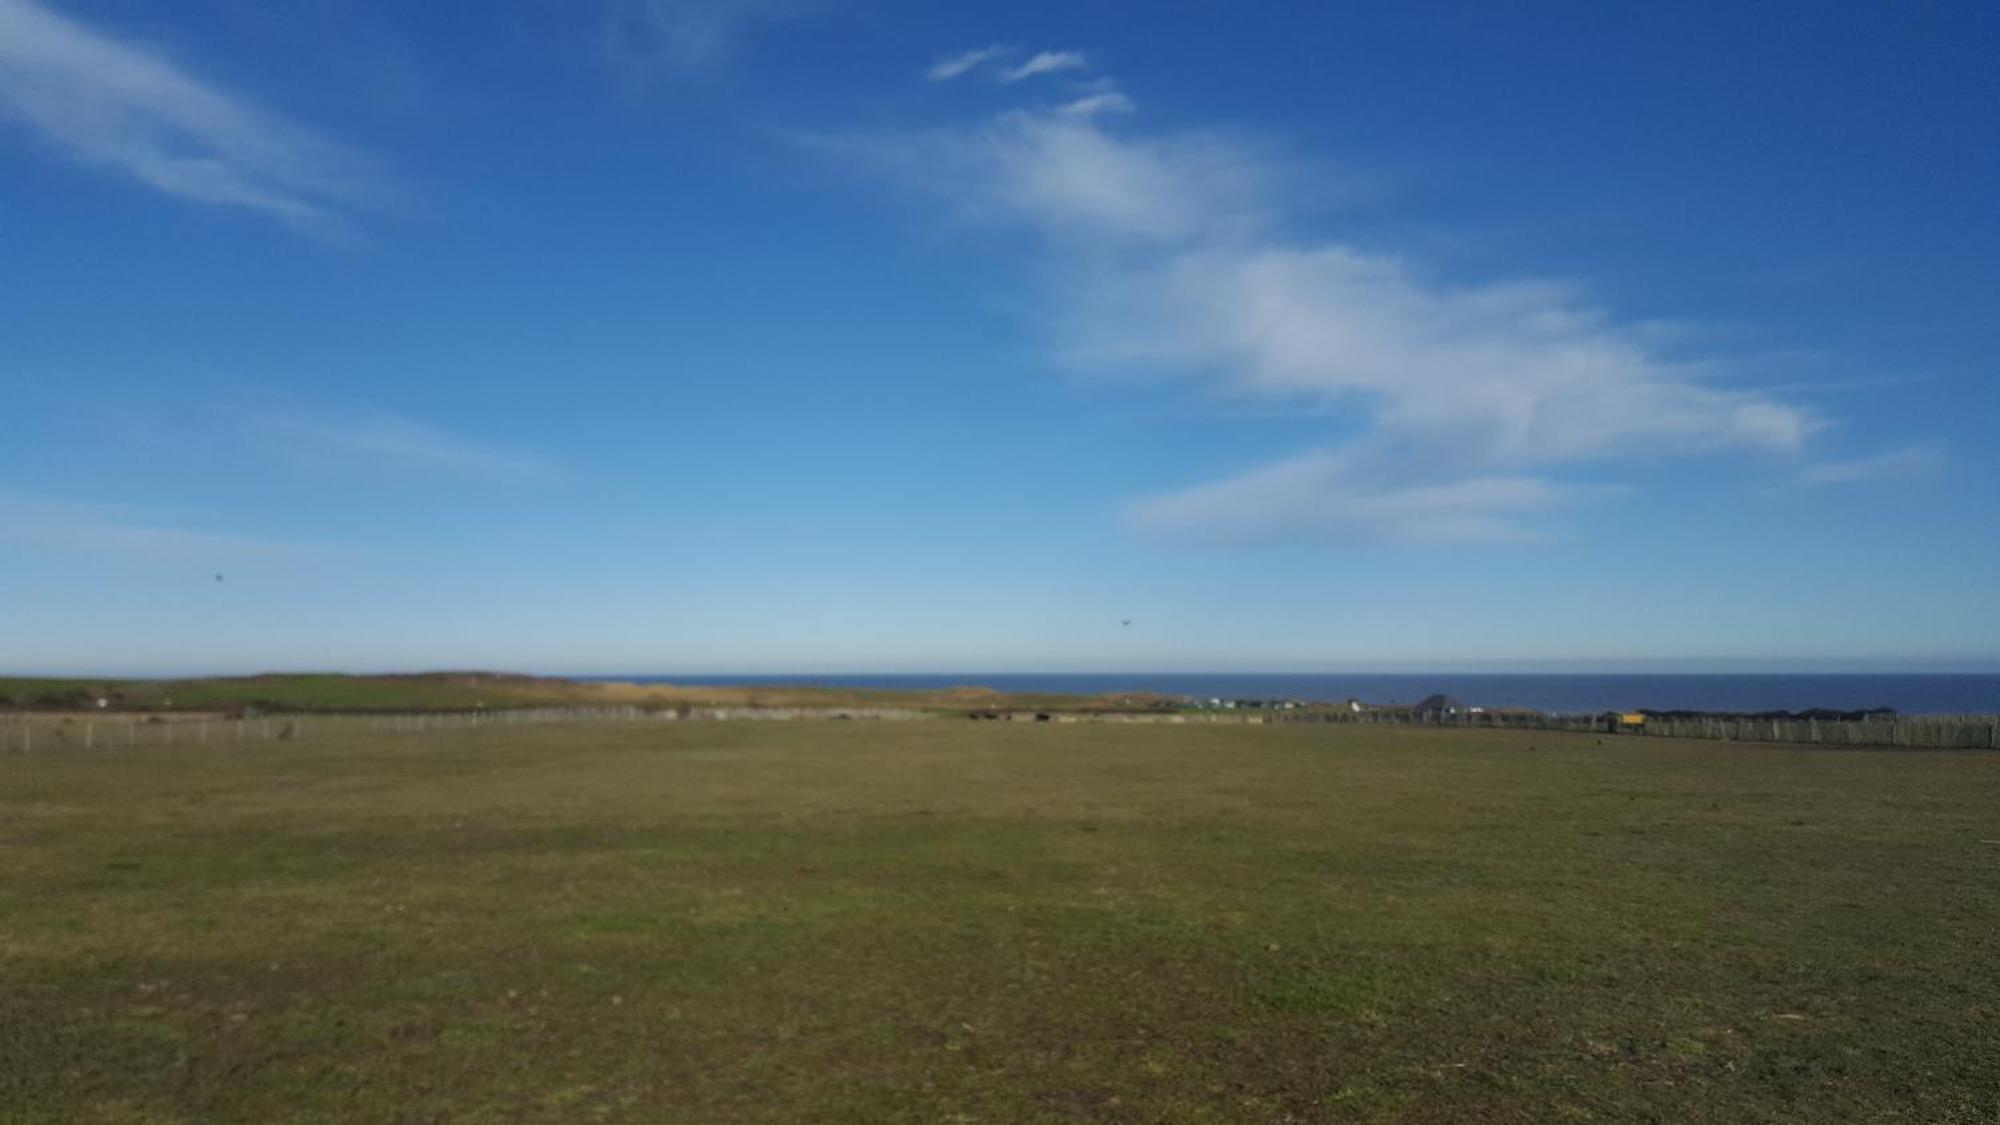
[820,52,1822,542]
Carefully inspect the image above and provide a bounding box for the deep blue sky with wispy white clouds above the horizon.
[0,0,2000,673]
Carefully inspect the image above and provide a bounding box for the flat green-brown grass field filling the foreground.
[0,721,2000,1123]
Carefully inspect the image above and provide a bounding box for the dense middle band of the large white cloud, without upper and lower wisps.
[1064,244,1814,466]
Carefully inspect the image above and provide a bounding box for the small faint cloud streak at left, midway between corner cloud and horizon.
[238,410,566,484]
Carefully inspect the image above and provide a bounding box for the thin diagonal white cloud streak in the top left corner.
[0,0,382,238]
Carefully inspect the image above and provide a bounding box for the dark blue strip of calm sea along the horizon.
[600,673,2000,715]
